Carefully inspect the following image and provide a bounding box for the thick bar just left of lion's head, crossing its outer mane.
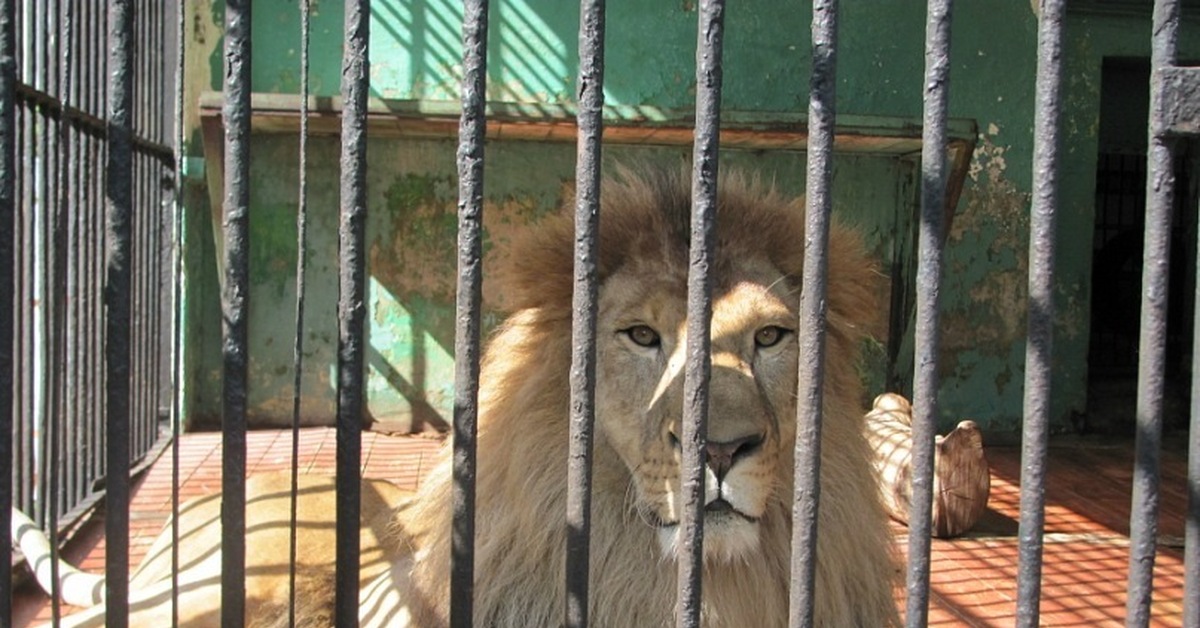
[450,0,488,628]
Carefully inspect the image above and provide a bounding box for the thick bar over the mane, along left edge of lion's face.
[565,0,605,628]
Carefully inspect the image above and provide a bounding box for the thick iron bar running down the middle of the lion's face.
[677,0,725,628]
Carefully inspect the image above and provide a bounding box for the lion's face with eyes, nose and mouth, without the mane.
[596,259,798,561]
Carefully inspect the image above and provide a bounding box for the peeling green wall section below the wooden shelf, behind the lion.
[182,134,898,429]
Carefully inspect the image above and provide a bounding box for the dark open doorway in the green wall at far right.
[1081,59,1196,433]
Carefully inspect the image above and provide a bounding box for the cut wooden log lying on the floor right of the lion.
[866,393,991,538]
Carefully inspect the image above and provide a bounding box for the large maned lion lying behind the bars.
[14,168,899,627]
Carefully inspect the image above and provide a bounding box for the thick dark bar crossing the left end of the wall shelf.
[221,0,252,628]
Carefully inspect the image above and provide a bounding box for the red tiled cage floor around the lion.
[13,429,1187,627]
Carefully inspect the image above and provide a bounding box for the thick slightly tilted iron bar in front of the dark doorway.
[1126,0,1180,626]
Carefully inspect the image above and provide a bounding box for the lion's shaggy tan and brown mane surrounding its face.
[394,169,896,627]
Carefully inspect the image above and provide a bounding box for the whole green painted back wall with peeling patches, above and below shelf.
[186,0,1200,431]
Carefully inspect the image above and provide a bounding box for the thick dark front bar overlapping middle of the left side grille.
[104,0,133,628]
